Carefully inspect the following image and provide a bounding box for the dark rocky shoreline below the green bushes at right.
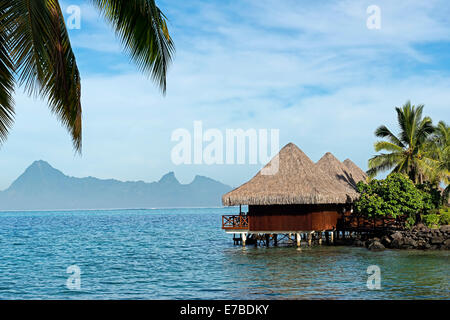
[337,224,450,251]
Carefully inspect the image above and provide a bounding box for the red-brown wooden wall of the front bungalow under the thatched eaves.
[248,205,343,231]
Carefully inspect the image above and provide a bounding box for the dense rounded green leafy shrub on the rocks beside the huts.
[355,173,436,226]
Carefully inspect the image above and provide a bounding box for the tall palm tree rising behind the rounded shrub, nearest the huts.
[367,101,434,183]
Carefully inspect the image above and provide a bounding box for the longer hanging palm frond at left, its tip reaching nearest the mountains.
[5,0,82,151]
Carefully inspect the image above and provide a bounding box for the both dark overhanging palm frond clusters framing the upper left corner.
[0,0,174,152]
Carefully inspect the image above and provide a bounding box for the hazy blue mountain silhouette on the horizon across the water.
[0,160,232,210]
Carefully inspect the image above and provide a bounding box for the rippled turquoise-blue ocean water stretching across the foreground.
[0,208,450,299]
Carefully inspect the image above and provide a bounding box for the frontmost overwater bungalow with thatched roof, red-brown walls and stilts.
[222,143,358,245]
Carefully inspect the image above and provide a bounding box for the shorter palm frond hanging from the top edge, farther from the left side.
[91,0,175,93]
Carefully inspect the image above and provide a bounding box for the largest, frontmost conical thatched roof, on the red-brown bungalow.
[222,143,356,206]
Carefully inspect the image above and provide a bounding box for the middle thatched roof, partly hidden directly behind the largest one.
[316,152,358,192]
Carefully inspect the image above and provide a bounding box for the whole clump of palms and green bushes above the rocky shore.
[355,101,450,228]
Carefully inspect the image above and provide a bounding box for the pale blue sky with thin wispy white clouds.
[0,0,450,189]
